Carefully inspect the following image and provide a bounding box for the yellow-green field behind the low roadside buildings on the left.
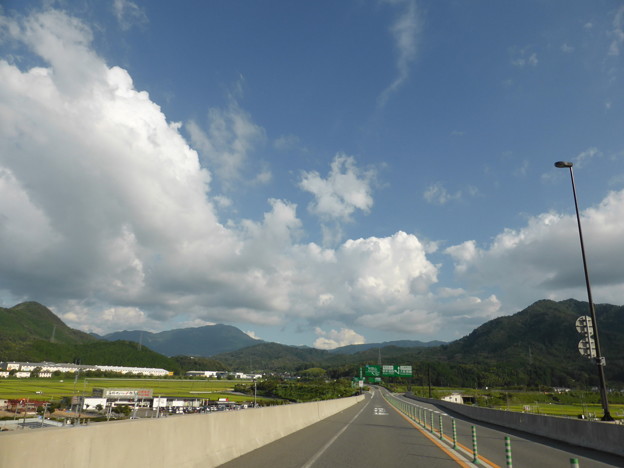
[0,377,260,401]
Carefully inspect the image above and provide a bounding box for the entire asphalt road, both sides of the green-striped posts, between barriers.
[221,389,624,468]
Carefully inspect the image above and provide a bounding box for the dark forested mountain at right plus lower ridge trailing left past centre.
[215,299,624,388]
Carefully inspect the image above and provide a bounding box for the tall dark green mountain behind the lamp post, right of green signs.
[355,299,624,388]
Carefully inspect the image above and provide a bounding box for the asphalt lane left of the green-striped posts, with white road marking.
[221,389,469,468]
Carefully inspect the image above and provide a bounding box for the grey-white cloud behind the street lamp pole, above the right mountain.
[446,191,624,308]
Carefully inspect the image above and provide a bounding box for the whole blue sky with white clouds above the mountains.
[0,0,624,349]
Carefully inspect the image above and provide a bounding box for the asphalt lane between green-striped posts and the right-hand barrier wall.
[395,395,624,468]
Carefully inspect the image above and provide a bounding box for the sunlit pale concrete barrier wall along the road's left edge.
[0,396,364,468]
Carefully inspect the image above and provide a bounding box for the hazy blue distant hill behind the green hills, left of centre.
[103,325,262,357]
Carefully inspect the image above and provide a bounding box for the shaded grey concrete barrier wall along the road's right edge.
[406,394,624,456]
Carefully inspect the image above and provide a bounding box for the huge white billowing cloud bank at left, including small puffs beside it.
[0,10,468,338]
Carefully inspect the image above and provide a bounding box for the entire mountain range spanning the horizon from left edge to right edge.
[0,299,624,387]
